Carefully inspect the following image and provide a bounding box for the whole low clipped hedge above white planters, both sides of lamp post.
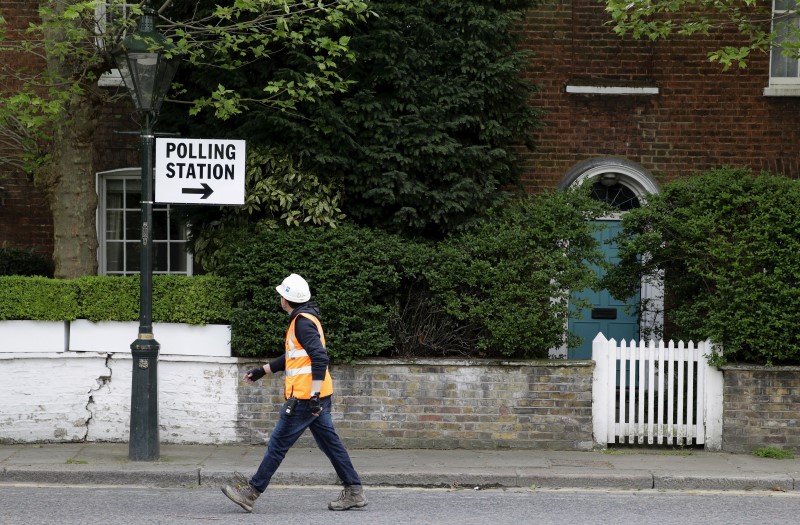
[0,275,231,324]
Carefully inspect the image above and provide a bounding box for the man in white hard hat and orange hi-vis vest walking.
[222,273,367,512]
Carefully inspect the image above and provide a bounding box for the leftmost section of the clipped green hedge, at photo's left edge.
[0,276,79,321]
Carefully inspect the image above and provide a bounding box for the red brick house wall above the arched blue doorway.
[522,0,800,191]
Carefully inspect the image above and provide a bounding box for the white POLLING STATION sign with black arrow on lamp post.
[155,138,246,206]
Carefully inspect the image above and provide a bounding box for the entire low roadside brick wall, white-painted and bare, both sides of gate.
[0,344,800,454]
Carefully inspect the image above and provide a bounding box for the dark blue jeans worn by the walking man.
[250,396,361,492]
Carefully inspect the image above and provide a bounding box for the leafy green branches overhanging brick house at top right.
[606,0,800,70]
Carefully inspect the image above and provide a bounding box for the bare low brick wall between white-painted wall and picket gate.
[234,359,594,450]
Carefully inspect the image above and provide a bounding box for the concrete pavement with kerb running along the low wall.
[0,443,800,491]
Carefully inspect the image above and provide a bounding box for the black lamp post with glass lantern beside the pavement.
[113,5,178,461]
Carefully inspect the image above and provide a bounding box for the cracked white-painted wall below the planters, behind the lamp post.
[0,352,244,444]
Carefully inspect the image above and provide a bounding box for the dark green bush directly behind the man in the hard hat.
[219,224,401,360]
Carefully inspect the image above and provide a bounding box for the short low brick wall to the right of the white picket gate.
[722,365,800,453]
